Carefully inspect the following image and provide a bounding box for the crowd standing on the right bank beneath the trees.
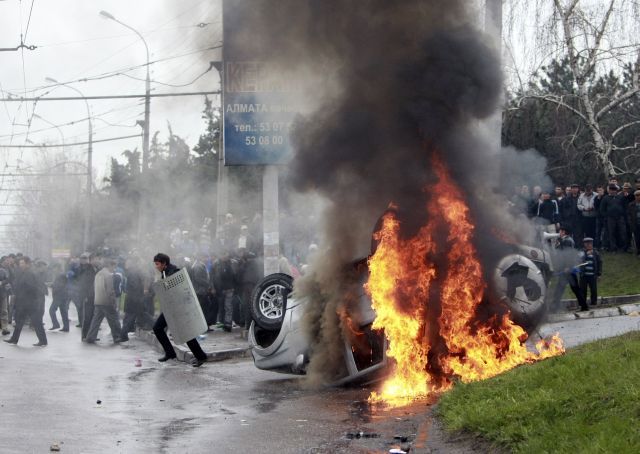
[510,178,640,256]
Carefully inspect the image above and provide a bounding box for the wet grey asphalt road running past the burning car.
[0,306,640,453]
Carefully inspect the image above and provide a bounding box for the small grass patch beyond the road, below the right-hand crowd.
[563,252,640,299]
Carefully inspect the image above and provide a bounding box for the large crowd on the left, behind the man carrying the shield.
[0,209,320,366]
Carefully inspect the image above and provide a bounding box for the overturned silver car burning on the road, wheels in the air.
[249,236,553,385]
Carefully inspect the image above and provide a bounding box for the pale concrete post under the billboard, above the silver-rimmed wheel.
[262,166,280,276]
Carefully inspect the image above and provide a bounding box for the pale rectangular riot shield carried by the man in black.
[153,268,208,344]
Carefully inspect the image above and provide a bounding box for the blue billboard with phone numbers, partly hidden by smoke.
[222,0,300,165]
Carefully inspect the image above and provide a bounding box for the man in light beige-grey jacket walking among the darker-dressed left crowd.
[85,259,121,344]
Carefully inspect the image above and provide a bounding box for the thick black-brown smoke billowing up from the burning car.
[240,0,544,382]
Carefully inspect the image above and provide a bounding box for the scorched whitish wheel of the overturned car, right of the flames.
[493,254,547,331]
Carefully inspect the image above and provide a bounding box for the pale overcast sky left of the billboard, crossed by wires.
[0,0,222,186]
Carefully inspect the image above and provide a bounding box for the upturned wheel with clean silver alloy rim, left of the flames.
[249,273,293,331]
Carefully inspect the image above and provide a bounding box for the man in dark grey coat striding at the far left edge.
[4,256,47,347]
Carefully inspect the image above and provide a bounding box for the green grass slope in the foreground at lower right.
[438,333,640,453]
